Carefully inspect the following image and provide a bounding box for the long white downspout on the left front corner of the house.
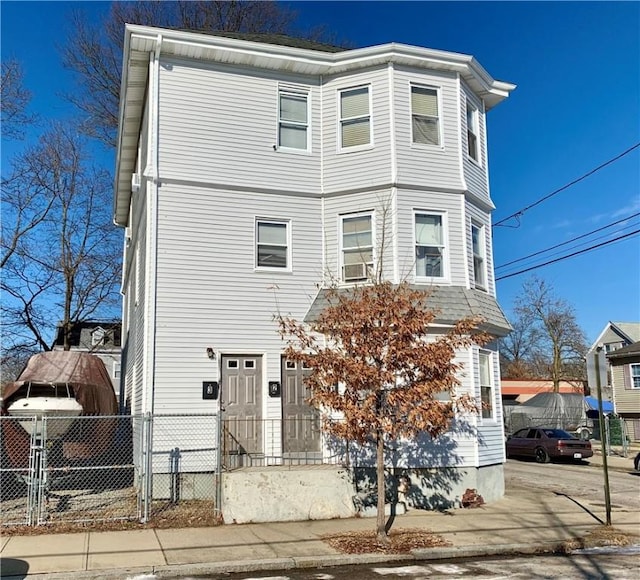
[142,34,162,413]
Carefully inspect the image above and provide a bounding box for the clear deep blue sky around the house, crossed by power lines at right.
[0,0,640,342]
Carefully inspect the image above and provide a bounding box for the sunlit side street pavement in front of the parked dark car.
[504,459,640,512]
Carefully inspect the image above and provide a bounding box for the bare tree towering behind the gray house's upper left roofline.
[62,0,336,146]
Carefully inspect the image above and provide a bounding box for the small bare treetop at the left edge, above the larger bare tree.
[0,59,36,139]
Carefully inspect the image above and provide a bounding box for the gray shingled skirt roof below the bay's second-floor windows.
[305,285,511,336]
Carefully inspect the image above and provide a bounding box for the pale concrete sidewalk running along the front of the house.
[0,455,640,580]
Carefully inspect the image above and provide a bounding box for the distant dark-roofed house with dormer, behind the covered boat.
[51,320,122,396]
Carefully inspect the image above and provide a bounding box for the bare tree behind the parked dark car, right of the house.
[514,277,588,392]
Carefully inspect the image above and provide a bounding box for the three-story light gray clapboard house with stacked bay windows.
[114,25,515,499]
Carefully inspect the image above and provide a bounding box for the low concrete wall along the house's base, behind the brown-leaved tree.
[222,464,504,524]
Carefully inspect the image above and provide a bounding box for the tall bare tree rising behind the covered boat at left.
[2,124,120,358]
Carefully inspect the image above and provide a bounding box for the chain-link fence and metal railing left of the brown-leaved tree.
[0,414,349,526]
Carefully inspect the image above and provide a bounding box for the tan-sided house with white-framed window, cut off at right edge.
[607,342,640,441]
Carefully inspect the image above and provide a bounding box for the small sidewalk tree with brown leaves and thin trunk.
[278,281,490,544]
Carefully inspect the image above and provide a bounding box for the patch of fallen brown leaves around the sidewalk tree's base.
[322,528,451,554]
